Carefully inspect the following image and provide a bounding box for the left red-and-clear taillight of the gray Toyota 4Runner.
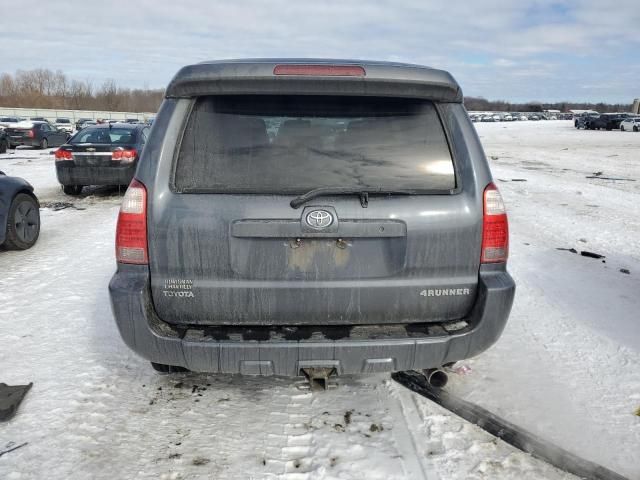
[116,179,149,265]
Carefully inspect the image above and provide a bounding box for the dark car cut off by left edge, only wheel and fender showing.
[0,172,40,250]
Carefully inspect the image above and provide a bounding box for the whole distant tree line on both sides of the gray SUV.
[0,68,631,113]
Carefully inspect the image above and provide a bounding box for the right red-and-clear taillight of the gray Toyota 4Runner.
[480,183,509,263]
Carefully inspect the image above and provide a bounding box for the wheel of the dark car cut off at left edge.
[4,193,40,250]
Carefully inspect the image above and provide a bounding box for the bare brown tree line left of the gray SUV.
[0,68,164,112]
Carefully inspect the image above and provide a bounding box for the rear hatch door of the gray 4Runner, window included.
[149,96,482,325]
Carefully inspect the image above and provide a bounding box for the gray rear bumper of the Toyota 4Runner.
[109,265,515,376]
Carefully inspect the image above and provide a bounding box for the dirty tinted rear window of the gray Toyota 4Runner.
[174,96,456,194]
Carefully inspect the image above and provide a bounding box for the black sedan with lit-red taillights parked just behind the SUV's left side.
[55,123,150,195]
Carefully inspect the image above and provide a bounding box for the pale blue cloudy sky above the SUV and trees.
[0,0,640,103]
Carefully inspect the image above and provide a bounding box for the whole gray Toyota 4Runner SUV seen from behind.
[109,59,515,376]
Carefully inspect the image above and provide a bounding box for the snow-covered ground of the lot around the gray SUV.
[0,121,640,480]
